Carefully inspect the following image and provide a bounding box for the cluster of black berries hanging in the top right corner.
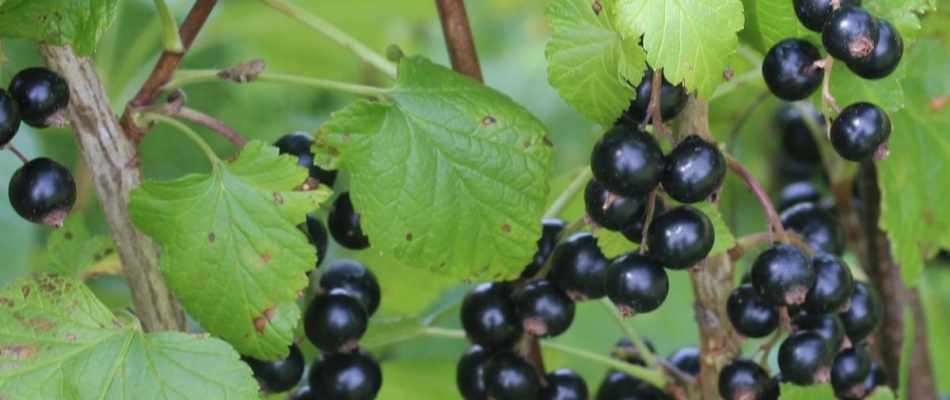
[762,0,904,162]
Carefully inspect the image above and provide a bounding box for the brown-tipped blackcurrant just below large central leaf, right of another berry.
[461,282,522,348]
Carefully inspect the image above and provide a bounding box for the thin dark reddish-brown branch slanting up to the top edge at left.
[120,0,218,142]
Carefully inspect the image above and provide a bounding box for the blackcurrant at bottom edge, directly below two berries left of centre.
[309,348,383,400]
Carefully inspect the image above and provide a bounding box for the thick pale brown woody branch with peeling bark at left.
[39,44,185,331]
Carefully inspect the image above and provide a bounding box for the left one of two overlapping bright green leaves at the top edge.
[544,0,646,125]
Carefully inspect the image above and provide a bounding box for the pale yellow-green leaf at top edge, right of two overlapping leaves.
[616,0,744,98]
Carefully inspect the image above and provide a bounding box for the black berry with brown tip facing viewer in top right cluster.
[821,7,880,63]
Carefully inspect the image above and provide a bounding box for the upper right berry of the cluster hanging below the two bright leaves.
[661,135,726,203]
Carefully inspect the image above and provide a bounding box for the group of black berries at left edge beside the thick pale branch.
[0,67,76,228]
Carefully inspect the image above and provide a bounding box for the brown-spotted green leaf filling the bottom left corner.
[0,274,258,400]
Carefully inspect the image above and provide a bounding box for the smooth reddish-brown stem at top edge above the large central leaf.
[435,0,482,82]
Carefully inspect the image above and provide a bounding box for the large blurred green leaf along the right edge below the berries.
[878,40,950,286]
